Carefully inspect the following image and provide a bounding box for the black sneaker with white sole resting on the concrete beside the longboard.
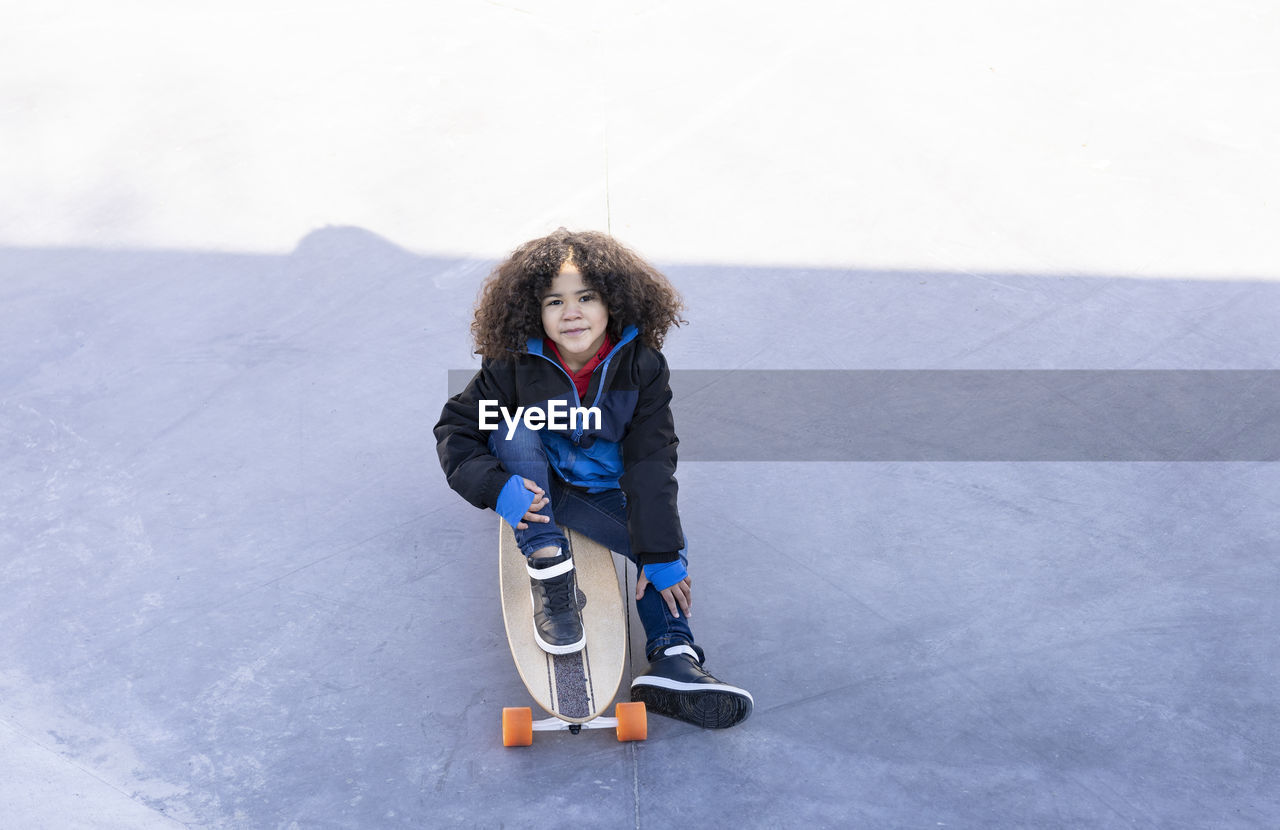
[631,646,755,729]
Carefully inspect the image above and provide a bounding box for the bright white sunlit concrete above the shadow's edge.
[0,0,1280,278]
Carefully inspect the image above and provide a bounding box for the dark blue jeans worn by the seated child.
[489,423,694,656]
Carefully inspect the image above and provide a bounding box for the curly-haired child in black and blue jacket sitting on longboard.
[435,228,754,728]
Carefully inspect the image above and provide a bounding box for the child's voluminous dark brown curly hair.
[471,228,687,357]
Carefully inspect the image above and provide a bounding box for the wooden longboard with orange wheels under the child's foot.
[498,520,648,747]
